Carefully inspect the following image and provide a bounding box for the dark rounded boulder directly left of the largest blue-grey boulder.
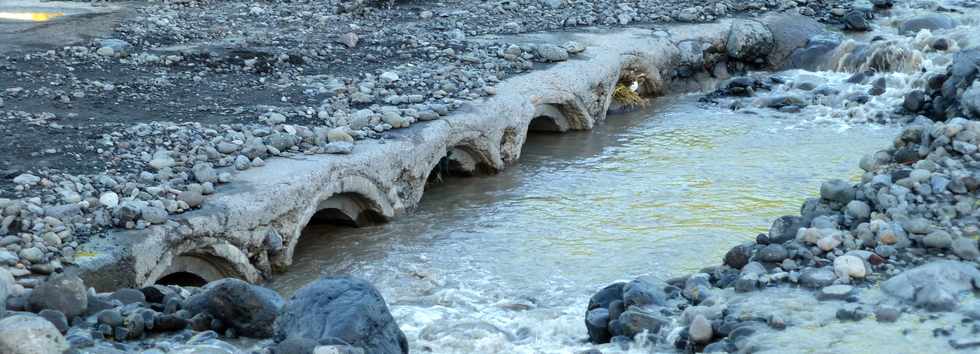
[186,278,284,338]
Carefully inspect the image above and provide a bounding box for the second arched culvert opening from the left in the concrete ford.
[310,193,384,227]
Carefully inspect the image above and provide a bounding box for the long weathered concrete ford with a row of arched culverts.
[73,15,816,289]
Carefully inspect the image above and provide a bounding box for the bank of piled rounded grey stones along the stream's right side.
[585,44,980,352]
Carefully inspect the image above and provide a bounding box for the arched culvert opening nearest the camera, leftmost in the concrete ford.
[154,254,237,286]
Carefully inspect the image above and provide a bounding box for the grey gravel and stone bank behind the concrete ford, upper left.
[0,1,850,287]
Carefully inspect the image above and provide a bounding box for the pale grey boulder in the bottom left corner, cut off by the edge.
[0,314,68,354]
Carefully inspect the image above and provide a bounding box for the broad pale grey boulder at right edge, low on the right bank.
[881,261,980,311]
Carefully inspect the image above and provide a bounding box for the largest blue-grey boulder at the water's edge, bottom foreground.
[276,277,408,354]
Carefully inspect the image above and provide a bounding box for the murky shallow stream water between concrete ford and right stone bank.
[267,96,897,353]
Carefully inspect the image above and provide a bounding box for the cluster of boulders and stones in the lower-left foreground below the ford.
[0,271,408,354]
